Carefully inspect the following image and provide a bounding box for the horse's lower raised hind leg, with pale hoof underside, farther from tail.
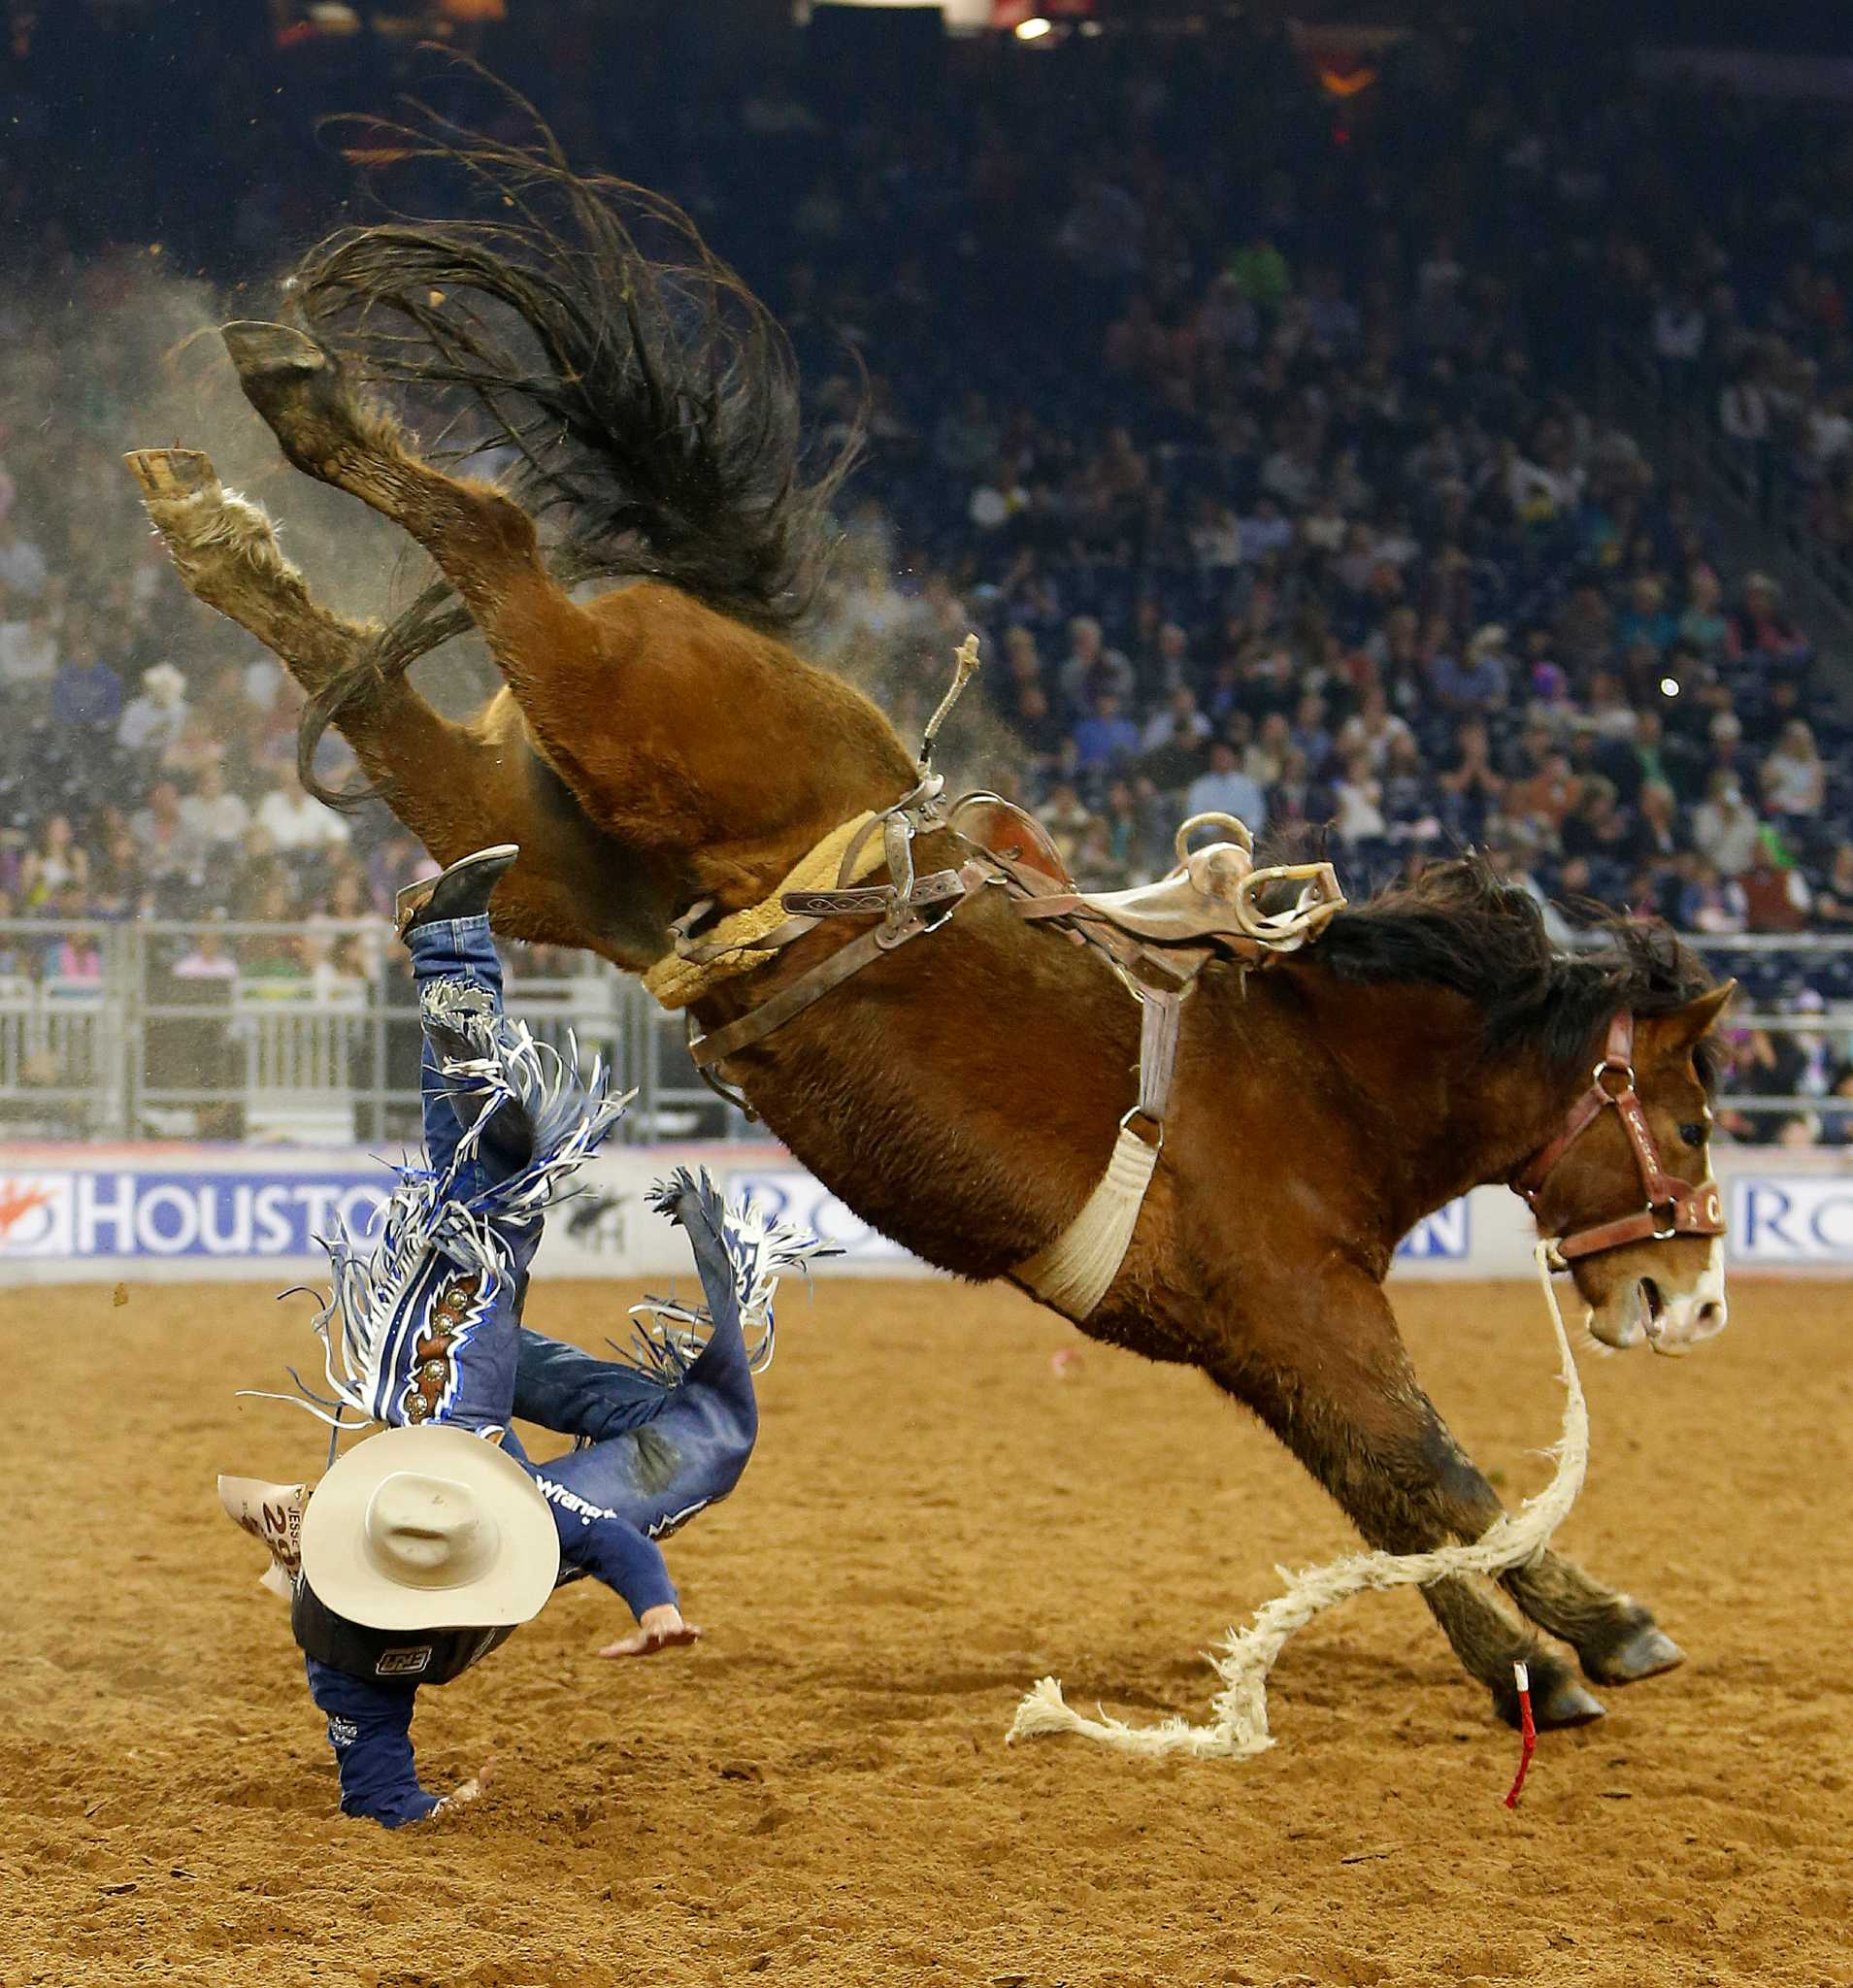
[127,449,644,944]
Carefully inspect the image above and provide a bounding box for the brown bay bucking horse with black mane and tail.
[131,132,1730,1724]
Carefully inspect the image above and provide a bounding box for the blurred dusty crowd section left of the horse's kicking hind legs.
[0,438,423,992]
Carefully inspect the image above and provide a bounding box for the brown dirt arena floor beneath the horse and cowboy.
[0,1280,1853,1988]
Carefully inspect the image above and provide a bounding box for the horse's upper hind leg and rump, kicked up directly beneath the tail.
[220,324,910,902]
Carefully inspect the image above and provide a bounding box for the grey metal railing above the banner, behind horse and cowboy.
[0,918,1853,1145]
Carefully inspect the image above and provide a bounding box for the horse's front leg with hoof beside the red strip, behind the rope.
[1208,1269,1603,1726]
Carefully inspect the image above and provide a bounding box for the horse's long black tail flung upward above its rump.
[292,87,861,644]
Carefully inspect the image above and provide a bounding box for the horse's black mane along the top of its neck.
[1308,857,1712,1085]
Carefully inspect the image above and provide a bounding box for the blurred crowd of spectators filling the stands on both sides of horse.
[0,10,1853,1140]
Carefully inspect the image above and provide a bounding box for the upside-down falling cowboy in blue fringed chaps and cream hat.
[220,846,821,1827]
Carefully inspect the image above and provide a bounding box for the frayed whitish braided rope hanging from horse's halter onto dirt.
[1008,1242,1589,1759]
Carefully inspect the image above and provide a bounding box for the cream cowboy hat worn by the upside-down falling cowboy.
[302,1425,561,1630]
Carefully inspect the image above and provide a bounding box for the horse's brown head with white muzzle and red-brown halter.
[1515,982,1736,1354]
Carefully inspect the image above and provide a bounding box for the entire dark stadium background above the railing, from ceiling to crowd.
[0,0,1853,1145]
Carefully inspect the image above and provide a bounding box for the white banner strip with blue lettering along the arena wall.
[0,1145,1853,1286]
